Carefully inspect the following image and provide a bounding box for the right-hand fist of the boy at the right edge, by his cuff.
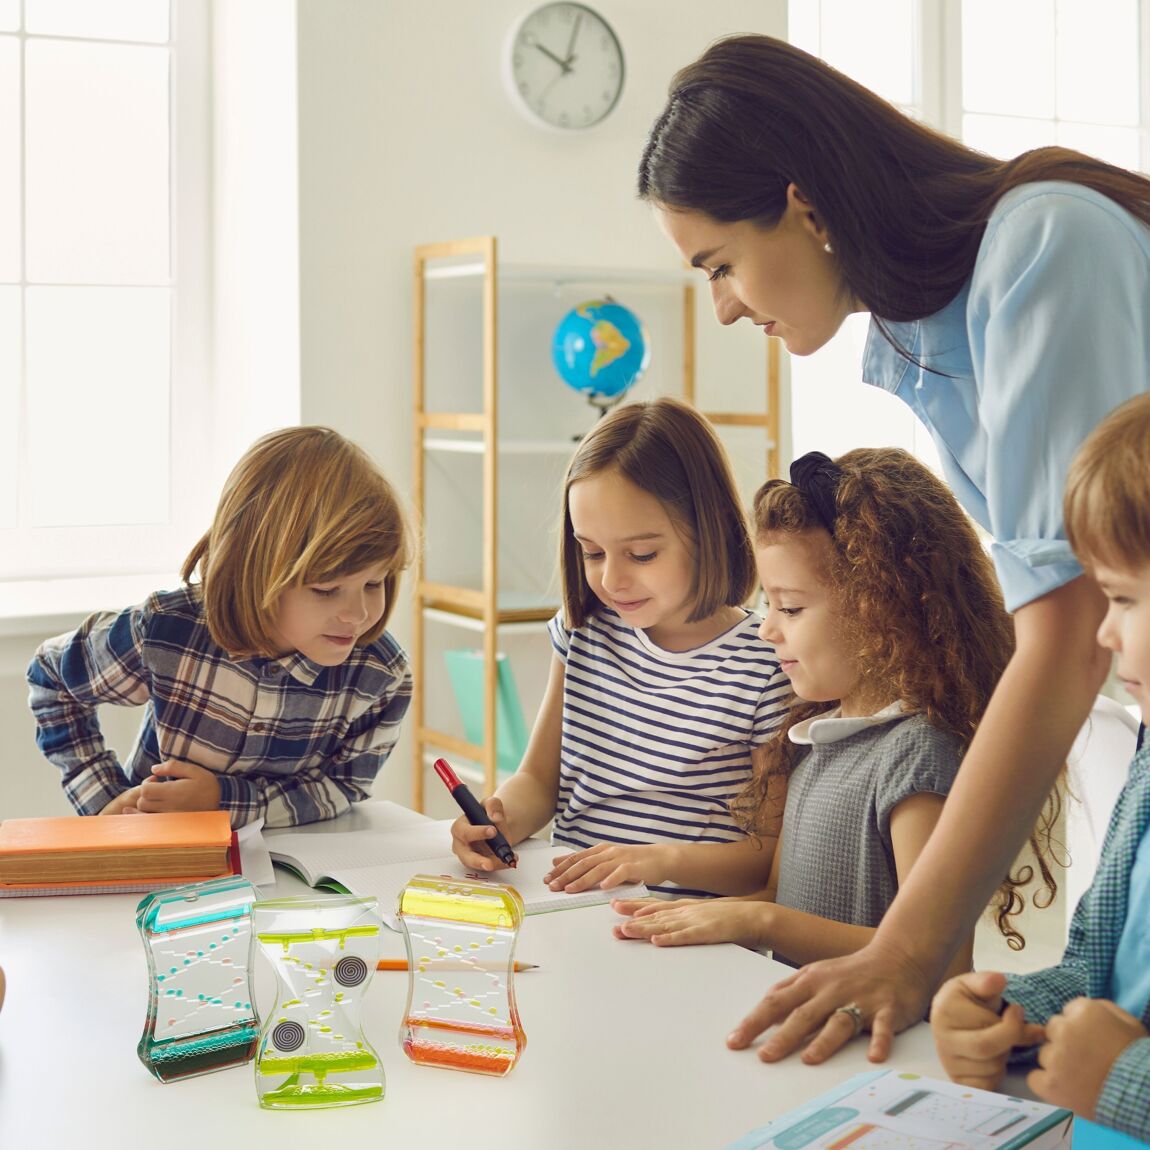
[1026,998,1148,1120]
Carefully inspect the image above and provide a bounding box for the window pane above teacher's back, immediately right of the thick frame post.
[963,0,1055,116]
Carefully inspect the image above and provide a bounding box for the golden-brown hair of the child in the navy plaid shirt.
[181,427,412,658]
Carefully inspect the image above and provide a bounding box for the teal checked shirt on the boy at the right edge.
[1005,743,1150,1140]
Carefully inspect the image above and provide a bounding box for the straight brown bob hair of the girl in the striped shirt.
[559,399,756,628]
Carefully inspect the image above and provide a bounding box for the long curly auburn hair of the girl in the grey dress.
[733,447,1061,950]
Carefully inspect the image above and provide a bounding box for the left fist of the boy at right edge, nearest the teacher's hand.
[930,971,1043,1090]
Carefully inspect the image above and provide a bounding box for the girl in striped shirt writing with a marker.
[452,399,790,894]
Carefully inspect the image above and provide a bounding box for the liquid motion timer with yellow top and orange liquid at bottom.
[399,874,527,1074]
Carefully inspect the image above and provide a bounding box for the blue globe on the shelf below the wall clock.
[551,296,651,411]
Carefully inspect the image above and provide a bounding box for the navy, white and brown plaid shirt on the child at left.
[28,588,412,827]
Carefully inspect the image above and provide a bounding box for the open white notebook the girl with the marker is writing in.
[265,819,647,929]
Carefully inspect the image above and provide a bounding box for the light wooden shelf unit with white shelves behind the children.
[411,236,780,811]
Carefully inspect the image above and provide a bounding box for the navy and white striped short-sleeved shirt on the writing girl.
[550,607,791,894]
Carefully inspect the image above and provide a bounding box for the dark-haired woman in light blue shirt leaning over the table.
[638,36,1150,1063]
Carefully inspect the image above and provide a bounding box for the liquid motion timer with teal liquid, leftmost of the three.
[136,875,260,1082]
